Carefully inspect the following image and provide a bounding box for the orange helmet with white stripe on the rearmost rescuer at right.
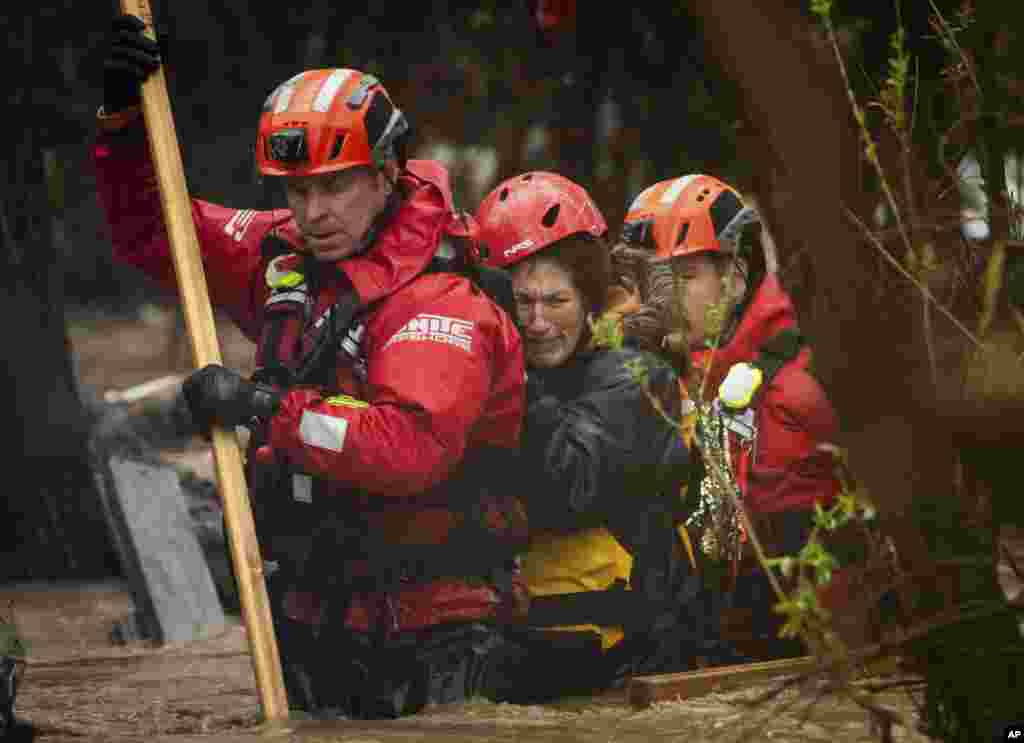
[650,175,759,261]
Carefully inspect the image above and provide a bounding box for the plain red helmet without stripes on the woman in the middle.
[476,171,608,268]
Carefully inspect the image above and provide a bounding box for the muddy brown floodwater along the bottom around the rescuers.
[0,583,942,743]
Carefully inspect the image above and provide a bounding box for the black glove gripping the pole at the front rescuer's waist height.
[181,363,281,431]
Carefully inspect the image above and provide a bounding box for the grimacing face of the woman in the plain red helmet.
[512,258,587,368]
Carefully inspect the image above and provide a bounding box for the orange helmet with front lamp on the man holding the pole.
[256,69,409,175]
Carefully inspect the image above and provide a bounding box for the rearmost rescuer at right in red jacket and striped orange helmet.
[647,175,843,656]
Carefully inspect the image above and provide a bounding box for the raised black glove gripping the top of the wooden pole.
[103,14,161,114]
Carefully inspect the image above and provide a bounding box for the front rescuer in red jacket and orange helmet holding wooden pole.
[93,16,524,717]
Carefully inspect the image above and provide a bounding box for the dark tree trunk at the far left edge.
[0,8,117,580]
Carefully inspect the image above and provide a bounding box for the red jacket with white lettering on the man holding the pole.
[93,120,524,630]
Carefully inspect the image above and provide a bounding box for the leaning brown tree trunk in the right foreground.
[690,0,1021,740]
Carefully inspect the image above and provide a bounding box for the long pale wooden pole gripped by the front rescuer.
[120,0,288,720]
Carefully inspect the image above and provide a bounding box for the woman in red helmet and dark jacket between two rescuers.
[468,172,716,703]
